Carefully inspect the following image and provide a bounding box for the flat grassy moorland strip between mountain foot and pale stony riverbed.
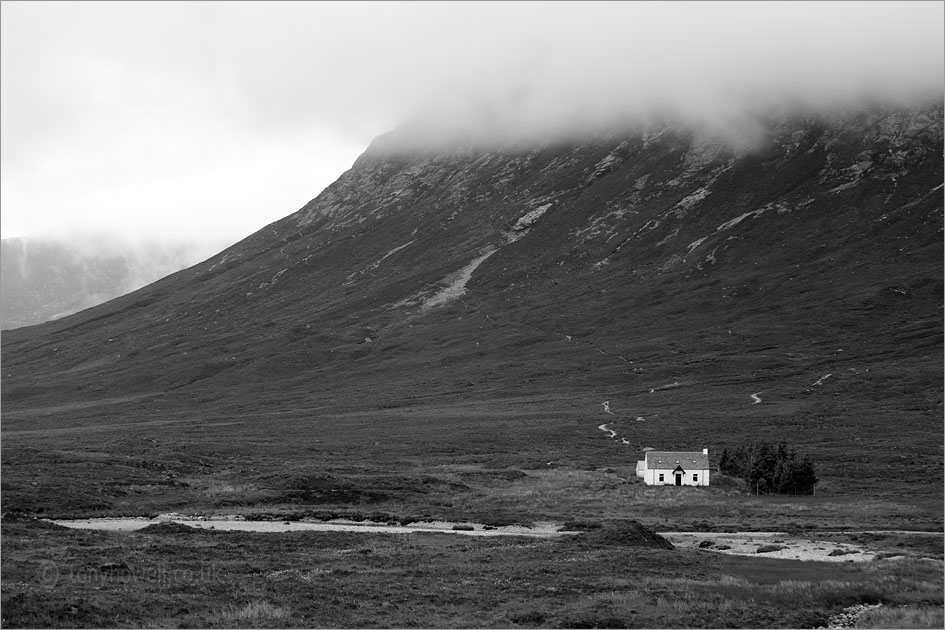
[3,396,942,530]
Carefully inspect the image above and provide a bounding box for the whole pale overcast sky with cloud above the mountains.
[0,1,945,249]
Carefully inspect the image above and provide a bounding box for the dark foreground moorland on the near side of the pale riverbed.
[3,520,942,628]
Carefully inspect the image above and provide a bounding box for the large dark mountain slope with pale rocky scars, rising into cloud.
[2,103,943,516]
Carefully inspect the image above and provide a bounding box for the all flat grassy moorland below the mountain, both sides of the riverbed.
[2,396,943,628]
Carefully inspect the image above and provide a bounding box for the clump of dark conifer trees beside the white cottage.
[719,442,817,494]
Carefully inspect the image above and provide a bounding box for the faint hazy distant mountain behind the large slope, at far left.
[0,234,224,330]
